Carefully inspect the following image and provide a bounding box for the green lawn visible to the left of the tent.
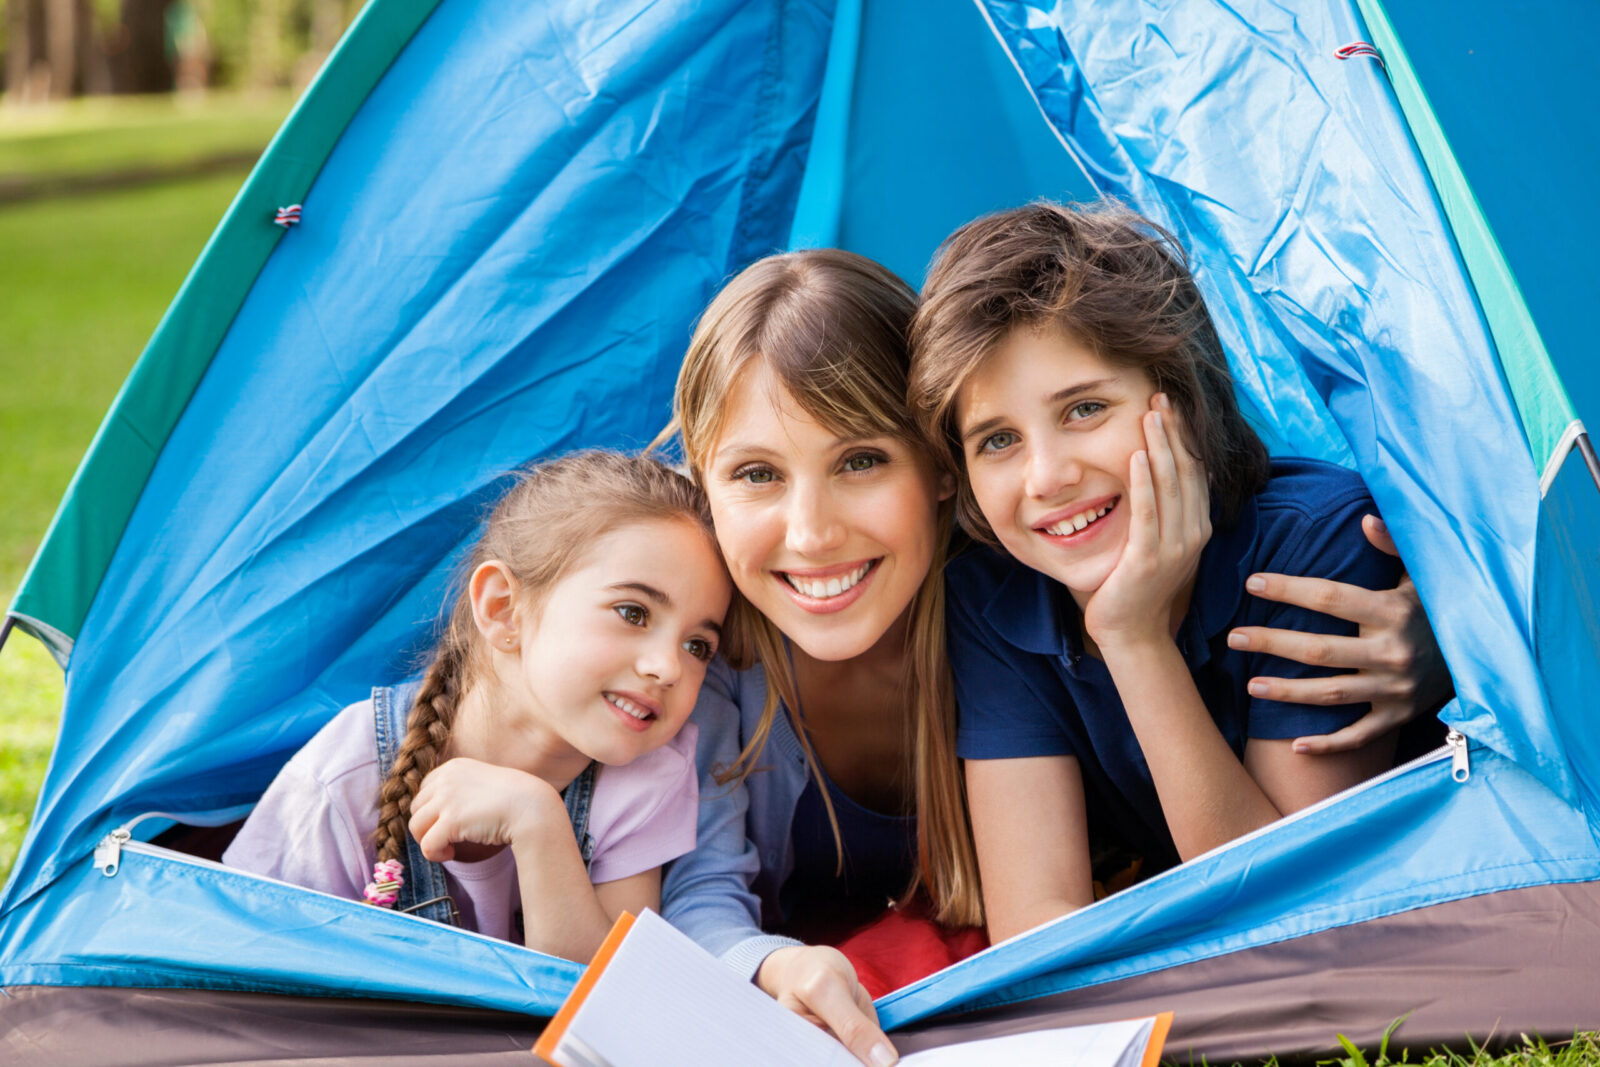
[0,87,290,880]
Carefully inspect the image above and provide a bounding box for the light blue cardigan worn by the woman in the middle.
[661,659,806,977]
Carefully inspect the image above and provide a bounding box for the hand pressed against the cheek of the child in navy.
[1083,394,1211,649]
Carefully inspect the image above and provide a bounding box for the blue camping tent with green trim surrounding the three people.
[0,0,1600,1057]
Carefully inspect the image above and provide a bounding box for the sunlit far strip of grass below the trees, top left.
[0,93,293,186]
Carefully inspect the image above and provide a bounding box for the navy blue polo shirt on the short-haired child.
[946,459,1402,870]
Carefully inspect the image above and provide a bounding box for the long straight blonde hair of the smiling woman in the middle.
[658,248,982,925]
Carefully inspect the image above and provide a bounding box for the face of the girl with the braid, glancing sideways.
[520,520,731,765]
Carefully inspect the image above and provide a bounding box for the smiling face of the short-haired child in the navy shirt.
[955,330,1155,603]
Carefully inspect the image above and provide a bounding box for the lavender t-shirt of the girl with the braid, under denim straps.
[222,701,699,941]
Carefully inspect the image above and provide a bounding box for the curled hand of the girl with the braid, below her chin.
[408,758,571,862]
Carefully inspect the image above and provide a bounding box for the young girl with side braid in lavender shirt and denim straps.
[222,451,731,960]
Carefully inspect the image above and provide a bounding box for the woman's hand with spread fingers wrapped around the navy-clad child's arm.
[1227,515,1454,755]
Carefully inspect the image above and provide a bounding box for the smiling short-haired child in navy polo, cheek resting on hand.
[910,203,1420,941]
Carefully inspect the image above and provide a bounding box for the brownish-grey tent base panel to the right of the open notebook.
[894,881,1600,1064]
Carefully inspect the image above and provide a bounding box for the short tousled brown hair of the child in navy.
[909,202,1267,544]
